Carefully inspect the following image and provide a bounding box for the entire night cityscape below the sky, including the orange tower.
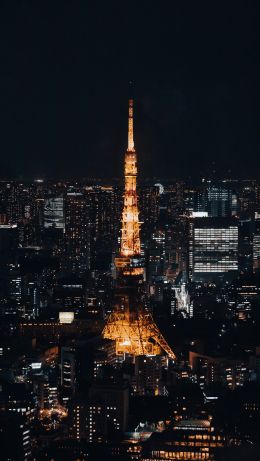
[0,100,260,461]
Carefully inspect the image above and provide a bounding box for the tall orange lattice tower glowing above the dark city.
[103,93,175,359]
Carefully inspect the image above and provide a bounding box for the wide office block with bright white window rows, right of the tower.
[189,218,238,281]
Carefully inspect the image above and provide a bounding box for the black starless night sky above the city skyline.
[0,0,260,179]
